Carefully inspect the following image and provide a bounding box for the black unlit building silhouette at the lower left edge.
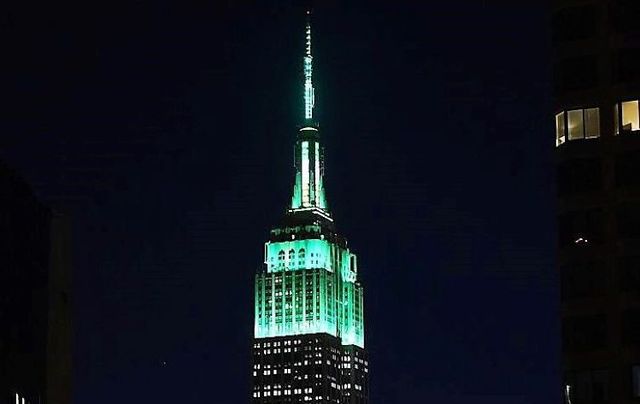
[0,163,72,404]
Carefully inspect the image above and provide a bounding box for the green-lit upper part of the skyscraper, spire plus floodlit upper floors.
[254,11,364,348]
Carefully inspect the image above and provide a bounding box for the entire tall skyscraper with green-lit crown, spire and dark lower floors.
[252,12,369,404]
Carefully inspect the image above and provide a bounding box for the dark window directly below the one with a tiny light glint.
[560,260,606,301]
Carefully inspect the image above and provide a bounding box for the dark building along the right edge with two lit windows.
[552,0,640,404]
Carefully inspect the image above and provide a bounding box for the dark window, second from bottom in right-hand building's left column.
[562,315,607,352]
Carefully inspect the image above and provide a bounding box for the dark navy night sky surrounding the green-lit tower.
[0,0,560,404]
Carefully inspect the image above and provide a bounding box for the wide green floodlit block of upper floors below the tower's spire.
[254,234,364,348]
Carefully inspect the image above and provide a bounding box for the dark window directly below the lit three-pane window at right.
[557,159,602,196]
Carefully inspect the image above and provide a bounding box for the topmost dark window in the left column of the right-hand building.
[551,5,596,42]
